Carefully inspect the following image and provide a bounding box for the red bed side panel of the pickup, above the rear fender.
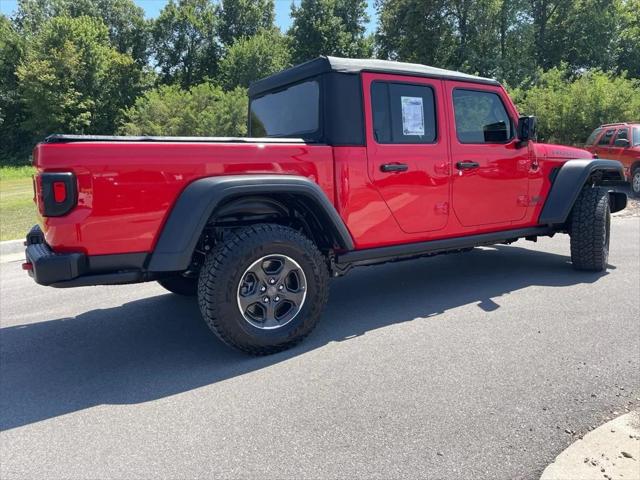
[34,142,334,255]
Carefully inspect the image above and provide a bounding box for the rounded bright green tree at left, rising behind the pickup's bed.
[17,16,144,138]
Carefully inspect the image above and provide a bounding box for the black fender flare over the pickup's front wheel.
[538,158,626,225]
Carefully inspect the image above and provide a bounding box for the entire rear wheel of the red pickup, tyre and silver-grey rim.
[198,224,329,355]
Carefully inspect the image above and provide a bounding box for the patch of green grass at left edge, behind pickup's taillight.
[0,167,37,240]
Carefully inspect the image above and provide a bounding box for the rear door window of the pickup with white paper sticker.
[371,82,437,143]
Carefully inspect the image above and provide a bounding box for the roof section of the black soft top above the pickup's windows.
[249,57,499,97]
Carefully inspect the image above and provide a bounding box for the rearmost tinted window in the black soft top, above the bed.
[249,80,320,137]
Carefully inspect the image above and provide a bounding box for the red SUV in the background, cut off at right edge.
[585,123,640,197]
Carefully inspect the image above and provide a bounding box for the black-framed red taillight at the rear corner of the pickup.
[36,172,78,217]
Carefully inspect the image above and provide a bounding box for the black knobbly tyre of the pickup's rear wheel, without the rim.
[198,224,329,355]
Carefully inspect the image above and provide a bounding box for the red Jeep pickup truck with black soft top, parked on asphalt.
[23,57,627,355]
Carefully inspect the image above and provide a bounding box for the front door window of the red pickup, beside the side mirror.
[453,88,513,143]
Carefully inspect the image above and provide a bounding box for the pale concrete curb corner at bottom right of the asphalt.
[540,411,640,480]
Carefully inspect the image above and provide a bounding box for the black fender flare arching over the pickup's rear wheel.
[148,175,353,272]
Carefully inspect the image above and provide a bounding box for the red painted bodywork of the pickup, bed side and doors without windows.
[34,73,591,255]
